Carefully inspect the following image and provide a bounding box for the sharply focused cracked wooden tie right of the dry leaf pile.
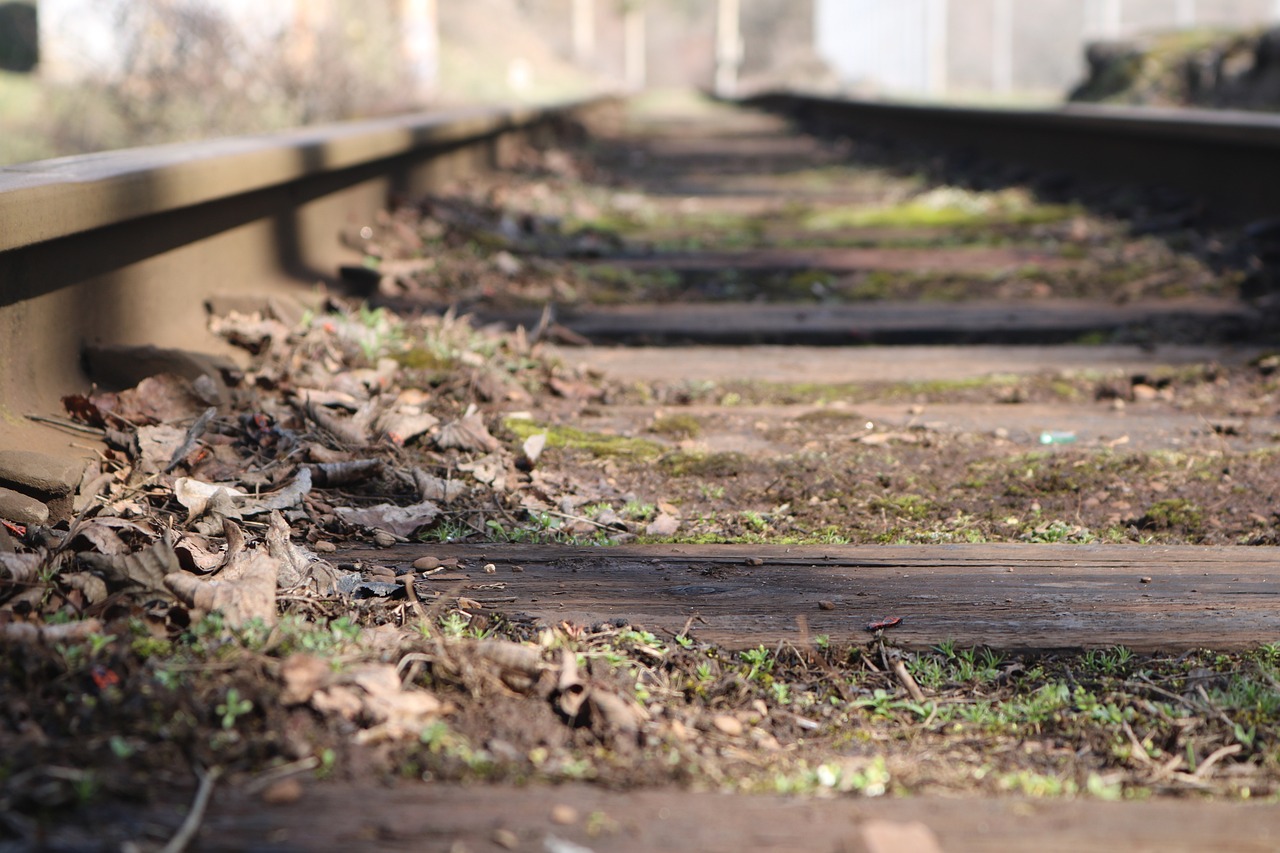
[346,544,1280,652]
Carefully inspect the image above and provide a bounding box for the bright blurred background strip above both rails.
[0,0,1280,164]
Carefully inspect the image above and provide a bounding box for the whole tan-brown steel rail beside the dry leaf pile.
[0,97,613,446]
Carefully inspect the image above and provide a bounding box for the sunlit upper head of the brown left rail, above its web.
[0,97,611,252]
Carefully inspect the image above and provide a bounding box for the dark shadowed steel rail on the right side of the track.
[742,92,1280,222]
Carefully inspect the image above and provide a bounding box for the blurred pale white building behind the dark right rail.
[814,0,1280,99]
